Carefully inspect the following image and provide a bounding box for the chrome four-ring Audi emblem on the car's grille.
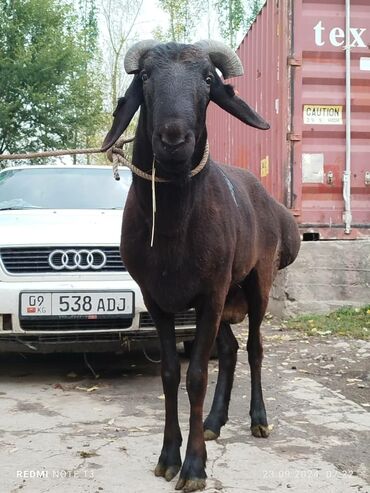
[48,249,107,270]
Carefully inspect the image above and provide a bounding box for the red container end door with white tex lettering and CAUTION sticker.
[291,0,370,238]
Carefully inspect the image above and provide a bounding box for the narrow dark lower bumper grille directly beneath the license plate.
[20,317,132,331]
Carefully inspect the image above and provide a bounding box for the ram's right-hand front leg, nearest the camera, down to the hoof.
[176,302,223,492]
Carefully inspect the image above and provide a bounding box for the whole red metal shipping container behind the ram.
[207,0,370,239]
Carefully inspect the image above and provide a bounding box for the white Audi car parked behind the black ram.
[0,165,195,352]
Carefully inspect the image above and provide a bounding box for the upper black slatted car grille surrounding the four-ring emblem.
[0,245,126,274]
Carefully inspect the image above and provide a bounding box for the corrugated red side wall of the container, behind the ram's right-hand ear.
[207,0,291,205]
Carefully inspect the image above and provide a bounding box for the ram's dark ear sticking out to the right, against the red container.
[210,74,270,130]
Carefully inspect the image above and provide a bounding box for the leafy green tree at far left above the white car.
[0,0,103,160]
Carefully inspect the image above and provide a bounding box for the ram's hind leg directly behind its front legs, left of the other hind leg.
[203,322,239,440]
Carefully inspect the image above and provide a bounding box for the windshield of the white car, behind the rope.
[0,166,131,210]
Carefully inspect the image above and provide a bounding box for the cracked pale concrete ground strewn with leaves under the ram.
[0,322,370,493]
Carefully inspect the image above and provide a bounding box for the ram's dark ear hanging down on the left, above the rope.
[101,75,143,152]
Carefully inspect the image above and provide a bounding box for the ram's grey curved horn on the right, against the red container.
[194,39,244,79]
